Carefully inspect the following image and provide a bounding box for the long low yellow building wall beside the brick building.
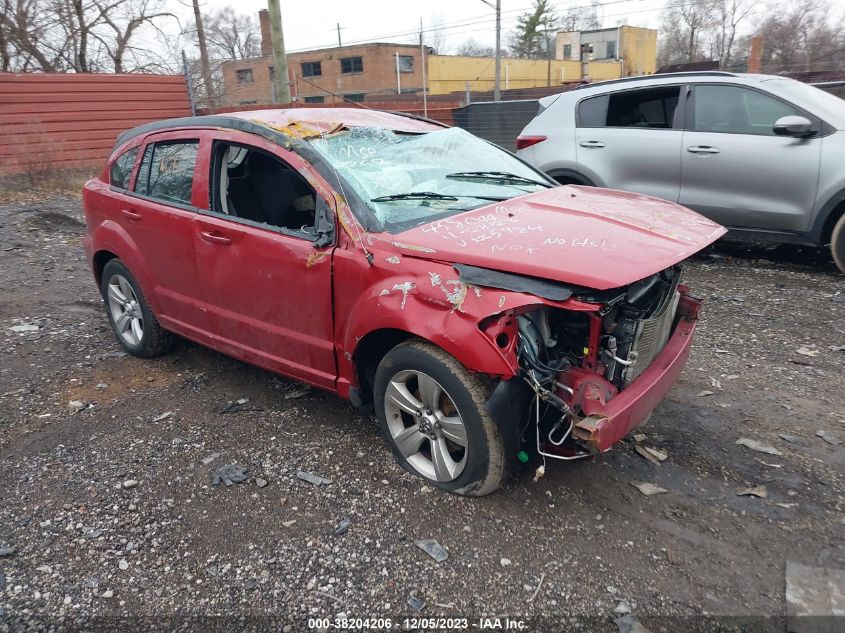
[427,55,623,94]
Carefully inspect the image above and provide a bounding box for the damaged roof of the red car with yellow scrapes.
[116,108,447,146]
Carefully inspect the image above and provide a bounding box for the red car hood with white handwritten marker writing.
[394,185,726,290]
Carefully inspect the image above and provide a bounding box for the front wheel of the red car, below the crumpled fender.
[374,340,516,496]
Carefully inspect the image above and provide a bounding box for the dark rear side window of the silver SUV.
[577,86,681,129]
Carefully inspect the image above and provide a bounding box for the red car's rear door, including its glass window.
[124,131,209,340]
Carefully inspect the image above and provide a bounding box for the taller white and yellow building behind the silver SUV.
[555,26,657,81]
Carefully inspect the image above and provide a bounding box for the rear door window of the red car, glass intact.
[135,140,199,205]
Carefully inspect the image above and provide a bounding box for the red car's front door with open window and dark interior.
[194,131,337,389]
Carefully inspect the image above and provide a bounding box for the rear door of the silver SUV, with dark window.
[575,85,683,202]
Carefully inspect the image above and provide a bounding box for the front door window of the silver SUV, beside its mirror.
[693,86,801,136]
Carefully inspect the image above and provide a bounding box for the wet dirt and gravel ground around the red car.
[0,198,845,633]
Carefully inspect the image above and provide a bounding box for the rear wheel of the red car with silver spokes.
[100,259,174,358]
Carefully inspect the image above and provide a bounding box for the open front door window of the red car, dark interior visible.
[211,142,317,238]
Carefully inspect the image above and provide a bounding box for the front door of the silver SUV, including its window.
[680,84,822,231]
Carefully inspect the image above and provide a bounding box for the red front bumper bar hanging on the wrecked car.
[572,293,701,453]
